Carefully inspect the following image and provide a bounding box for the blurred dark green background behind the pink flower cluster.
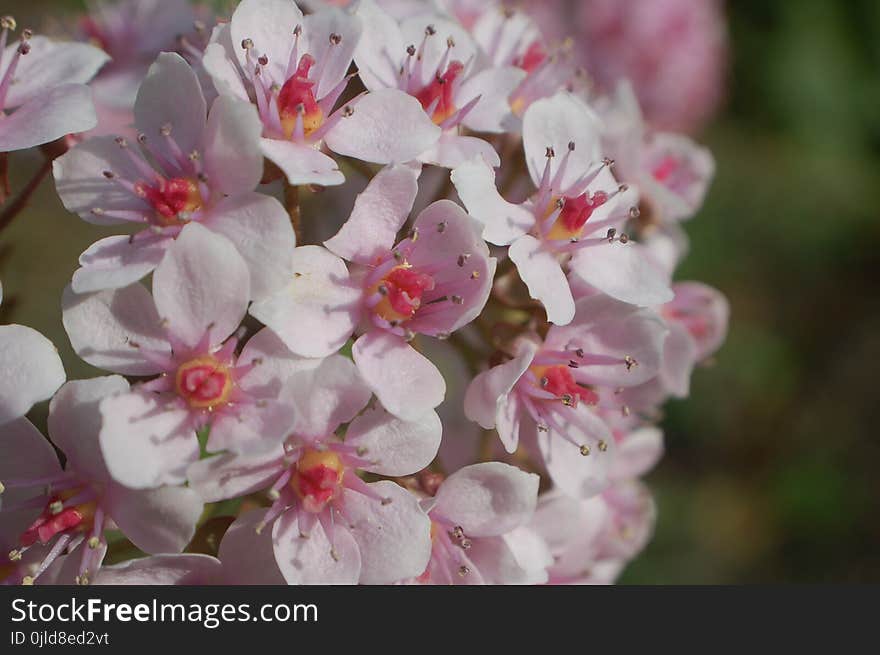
[0,0,880,583]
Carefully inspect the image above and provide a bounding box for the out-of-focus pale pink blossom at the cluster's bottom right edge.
[529,428,663,584]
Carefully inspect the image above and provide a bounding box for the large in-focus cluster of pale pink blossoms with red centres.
[0,0,728,584]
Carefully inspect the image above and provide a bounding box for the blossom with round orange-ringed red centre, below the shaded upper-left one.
[63,223,293,488]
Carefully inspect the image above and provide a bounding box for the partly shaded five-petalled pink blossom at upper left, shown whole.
[54,53,296,298]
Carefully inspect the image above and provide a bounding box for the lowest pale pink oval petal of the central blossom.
[352,330,446,420]
